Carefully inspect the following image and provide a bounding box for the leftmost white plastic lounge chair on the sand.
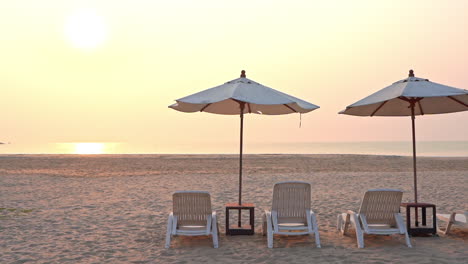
[166,191,218,248]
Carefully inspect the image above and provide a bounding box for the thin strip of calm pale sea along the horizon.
[0,141,468,157]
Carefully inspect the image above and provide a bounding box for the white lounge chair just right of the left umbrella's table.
[263,181,320,248]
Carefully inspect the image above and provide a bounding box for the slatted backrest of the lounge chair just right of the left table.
[272,181,310,223]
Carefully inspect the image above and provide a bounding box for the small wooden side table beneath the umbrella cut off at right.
[401,203,437,236]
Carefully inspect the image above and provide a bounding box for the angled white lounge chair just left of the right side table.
[337,189,411,248]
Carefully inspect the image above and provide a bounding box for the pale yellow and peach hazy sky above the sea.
[0,0,468,153]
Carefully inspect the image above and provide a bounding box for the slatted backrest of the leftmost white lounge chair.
[172,191,211,225]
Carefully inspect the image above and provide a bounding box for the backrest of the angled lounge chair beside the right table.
[359,189,403,226]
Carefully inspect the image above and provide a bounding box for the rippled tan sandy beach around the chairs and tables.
[0,155,468,263]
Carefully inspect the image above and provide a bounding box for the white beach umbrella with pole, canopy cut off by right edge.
[339,70,468,203]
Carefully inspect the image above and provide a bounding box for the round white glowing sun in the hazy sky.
[65,9,108,50]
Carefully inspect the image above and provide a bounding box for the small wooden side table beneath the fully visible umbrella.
[225,203,255,236]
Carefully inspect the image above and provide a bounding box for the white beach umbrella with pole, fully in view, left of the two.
[169,71,319,205]
